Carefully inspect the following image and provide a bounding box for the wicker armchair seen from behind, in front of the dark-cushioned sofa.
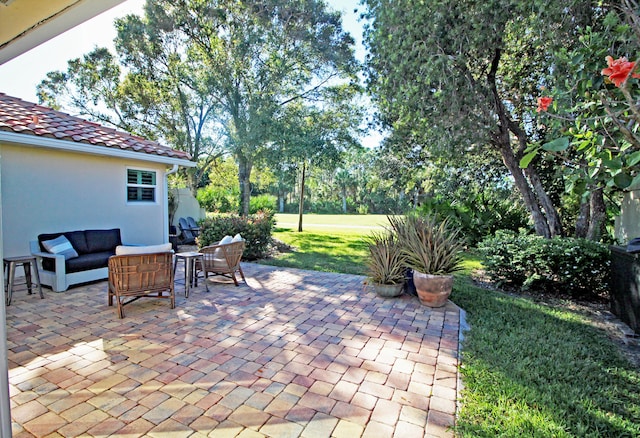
[109,252,176,318]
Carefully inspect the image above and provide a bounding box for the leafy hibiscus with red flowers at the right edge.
[523,0,640,240]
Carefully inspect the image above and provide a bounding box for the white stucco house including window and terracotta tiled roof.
[0,93,195,257]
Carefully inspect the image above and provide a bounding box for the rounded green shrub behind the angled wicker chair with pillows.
[197,211,274,260]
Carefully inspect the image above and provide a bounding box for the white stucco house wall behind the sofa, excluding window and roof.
[0,144,168,257]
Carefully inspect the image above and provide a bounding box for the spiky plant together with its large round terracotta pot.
[389,215,464,307]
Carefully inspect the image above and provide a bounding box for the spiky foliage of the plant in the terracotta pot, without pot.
[389,215,464,275]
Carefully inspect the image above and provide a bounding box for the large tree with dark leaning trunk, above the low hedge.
[366,0,597,237]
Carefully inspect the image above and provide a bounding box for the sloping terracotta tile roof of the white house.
[0,93,191,160]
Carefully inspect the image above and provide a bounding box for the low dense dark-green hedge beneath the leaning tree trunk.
[478,230,609,298]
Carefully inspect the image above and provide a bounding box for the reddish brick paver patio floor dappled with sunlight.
[7,263,461,438]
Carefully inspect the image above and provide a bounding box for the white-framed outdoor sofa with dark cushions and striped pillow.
[29,228,122,292]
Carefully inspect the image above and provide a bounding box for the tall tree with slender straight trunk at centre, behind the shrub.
[146,0,356,214]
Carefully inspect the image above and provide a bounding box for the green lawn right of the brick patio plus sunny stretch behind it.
[255,216,640,437]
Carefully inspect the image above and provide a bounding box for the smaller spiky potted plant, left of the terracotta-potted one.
[367,232,407,297]
